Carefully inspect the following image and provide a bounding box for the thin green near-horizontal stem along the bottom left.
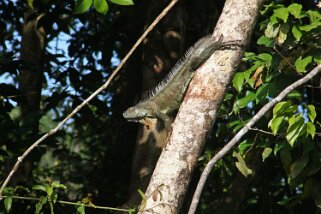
[2,195,130,213]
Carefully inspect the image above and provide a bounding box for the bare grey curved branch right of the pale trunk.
[188,65,321,214]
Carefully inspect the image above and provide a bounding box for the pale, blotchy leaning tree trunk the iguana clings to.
[140,0,262,213]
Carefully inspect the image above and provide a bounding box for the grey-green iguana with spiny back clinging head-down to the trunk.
[123,35,238,132]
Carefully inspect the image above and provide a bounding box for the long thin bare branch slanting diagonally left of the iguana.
[0,0,178,201]
